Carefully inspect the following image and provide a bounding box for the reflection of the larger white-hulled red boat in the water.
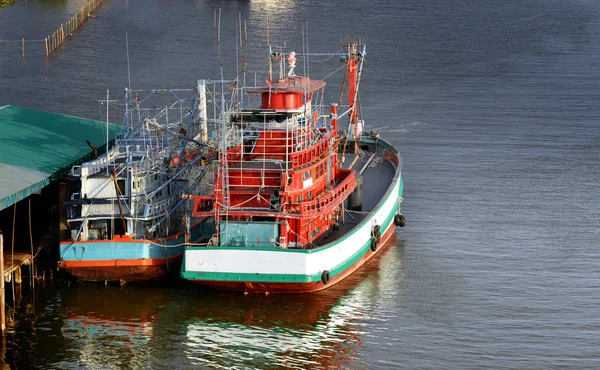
[185,236,401,369]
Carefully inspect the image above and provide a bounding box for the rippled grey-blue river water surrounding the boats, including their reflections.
[0,0,600,369]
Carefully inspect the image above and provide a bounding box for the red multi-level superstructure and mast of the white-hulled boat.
[192,47,361,248]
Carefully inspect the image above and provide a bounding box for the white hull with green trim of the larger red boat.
[181,139,403,293]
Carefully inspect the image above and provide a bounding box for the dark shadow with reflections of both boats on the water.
[6,233,401,369]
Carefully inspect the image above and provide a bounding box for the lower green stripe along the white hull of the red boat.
[181,199,398,283]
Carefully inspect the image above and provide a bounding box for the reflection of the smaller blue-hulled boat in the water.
[56,284,162,368]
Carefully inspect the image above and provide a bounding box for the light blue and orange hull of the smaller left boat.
[58,223,205,282]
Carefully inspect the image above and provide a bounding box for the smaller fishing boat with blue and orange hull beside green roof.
[58,89,212,282]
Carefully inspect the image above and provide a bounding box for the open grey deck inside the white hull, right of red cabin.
[314,153,396,246]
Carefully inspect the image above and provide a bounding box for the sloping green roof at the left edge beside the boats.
[0,106,124,210]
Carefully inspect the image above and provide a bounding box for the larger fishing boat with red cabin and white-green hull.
[181,41,405,293]
